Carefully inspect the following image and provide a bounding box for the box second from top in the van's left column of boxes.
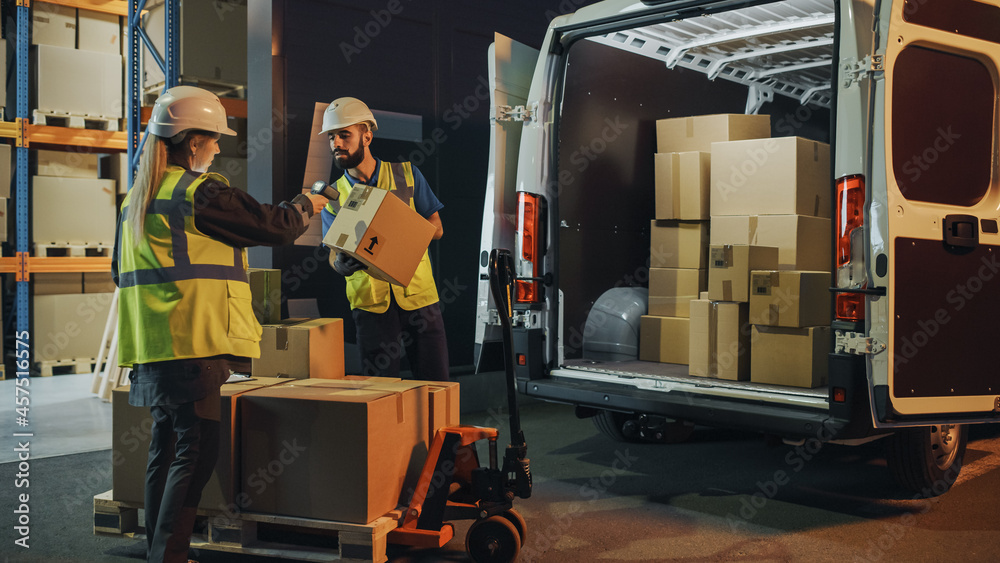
[653,152,712,221]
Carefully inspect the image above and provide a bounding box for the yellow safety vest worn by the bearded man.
[326,161,438,313]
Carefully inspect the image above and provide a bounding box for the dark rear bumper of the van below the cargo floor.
[518,377,857,442]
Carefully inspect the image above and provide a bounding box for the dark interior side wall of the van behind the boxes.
[558,40,832,359]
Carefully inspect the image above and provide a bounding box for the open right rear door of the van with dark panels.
[884,0,1000,421]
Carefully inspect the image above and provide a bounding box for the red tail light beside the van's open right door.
[836,174,868,321]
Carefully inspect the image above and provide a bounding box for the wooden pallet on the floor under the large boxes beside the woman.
[94,491,402,563]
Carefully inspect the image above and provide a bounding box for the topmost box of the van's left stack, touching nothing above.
[656,114,771,152]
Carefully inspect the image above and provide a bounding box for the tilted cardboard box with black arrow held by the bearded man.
[323,185,436,287]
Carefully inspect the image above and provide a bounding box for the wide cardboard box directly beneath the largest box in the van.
[710,215,833,271]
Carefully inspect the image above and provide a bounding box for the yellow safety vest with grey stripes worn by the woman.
[118,166,261,367]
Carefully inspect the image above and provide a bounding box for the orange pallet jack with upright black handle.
[387,249,531,563]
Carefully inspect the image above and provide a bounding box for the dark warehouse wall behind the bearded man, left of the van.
[272,0,594,373]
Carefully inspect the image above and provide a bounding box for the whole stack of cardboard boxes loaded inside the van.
[640,115,831,387]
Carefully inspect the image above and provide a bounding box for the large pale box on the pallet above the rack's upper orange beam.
[37,45,124,119]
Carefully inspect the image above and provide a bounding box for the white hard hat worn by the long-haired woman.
[147,86,236,139]
